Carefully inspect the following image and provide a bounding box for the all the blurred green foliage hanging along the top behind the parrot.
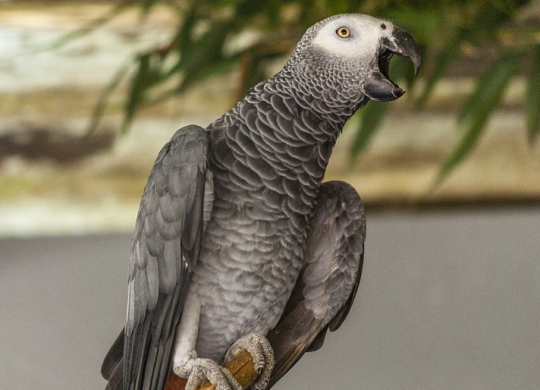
[53,0,540,180]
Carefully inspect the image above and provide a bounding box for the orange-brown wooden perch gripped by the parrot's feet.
[165,350,257,390]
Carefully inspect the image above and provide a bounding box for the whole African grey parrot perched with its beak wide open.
[102,14,420,390]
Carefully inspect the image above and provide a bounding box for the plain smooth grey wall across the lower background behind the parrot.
[0,208,540,390]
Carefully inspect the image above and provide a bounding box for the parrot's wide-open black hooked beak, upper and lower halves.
[364,27,421,101]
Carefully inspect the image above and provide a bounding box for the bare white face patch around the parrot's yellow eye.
[312,15,394,59]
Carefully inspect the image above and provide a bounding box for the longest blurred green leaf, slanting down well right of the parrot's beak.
[437,52,524,183]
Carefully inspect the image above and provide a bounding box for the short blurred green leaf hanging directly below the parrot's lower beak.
[351,101,388,161]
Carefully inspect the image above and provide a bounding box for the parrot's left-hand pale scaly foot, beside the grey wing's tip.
[173,354,243,390]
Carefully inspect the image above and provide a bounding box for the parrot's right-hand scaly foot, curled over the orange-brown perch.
[225,333,275,390]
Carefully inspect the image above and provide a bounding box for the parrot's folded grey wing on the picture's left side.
[102,126,212,390]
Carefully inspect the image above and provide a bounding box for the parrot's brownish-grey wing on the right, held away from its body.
[268,181,366,389]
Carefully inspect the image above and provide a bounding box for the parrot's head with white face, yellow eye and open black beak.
[288,14,420,108]
